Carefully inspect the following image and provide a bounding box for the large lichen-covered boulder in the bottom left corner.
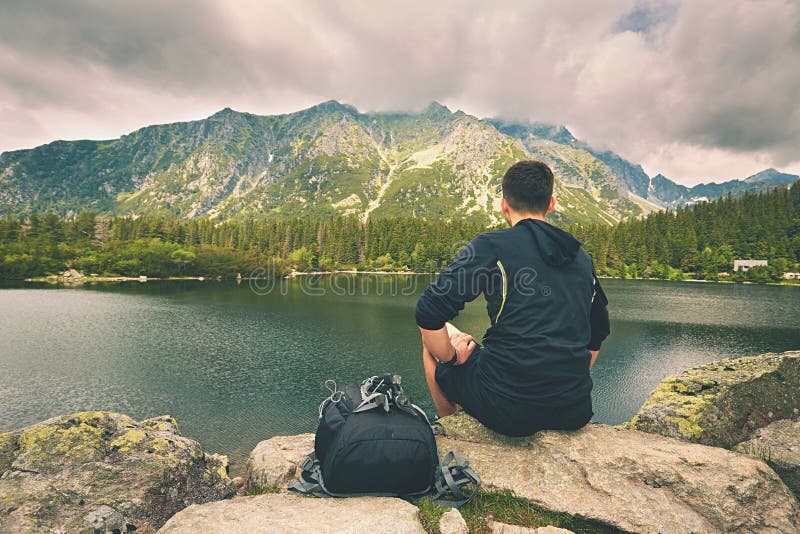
[0,412,233,533]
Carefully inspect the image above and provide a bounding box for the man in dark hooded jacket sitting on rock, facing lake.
[416,161,610,436]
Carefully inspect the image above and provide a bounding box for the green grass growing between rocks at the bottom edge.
[417,490,621,534]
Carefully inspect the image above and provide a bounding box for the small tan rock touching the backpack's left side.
[245,434,314,491]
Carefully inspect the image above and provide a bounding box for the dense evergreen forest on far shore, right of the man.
[571,182,800,282]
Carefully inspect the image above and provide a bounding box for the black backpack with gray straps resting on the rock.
[289,374,480,507]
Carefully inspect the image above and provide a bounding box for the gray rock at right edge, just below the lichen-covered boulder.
[734,419,800,498]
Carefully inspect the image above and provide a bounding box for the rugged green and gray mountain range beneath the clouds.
[0,101,798,224]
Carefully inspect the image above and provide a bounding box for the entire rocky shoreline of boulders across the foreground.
[0,352,800,533]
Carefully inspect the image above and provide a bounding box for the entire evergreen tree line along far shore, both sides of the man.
[0,182,800,281]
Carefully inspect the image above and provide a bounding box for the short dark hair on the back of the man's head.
[503,160,554,213]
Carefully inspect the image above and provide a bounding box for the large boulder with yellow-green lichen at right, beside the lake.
[627,351,800,449]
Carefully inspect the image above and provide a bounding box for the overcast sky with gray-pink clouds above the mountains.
[0,0,800,184]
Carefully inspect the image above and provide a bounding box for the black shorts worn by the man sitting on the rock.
[435,347,594,436]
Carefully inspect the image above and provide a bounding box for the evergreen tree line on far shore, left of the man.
[0,212,484,279]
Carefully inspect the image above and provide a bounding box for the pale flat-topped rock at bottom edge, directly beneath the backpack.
[158,493,425,534]
